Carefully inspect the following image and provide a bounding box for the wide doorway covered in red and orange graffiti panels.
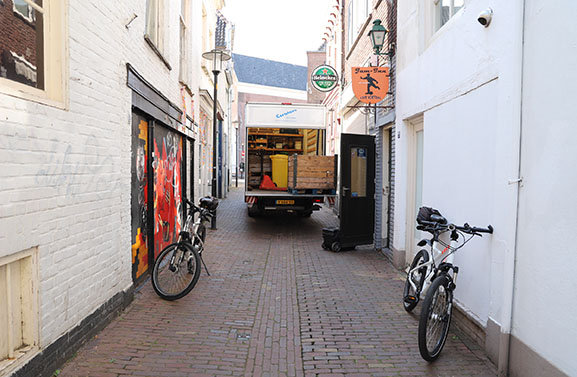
[131,112,184,282]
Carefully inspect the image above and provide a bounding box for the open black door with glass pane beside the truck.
[339,134,375,247]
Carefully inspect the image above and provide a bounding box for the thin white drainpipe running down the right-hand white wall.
[497,0,526,377]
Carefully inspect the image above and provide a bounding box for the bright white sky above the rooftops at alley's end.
[222,0,336,66]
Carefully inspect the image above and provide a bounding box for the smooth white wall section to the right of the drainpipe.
[512,0,577,375]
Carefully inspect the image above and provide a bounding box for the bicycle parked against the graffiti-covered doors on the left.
[151,197,218,301]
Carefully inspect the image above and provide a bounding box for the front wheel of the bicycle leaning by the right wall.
[419,274,453,361]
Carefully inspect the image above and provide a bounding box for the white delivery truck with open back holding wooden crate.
[245,102,337,217]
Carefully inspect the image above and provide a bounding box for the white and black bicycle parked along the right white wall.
[403,207,493,361]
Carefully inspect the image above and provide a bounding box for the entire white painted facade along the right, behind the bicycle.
[393,0,577,375]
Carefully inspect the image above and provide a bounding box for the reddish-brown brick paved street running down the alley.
[59,188,495,377]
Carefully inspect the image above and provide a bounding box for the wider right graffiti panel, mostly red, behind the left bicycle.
[152,127,183,258]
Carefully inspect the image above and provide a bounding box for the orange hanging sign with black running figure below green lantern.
[352,67,389,103]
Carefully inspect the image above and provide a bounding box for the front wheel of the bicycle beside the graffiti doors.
[152,243,200,301]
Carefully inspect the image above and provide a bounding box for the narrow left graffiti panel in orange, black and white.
[131,114,148,281]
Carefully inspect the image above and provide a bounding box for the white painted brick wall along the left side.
[0,0,206,346]
